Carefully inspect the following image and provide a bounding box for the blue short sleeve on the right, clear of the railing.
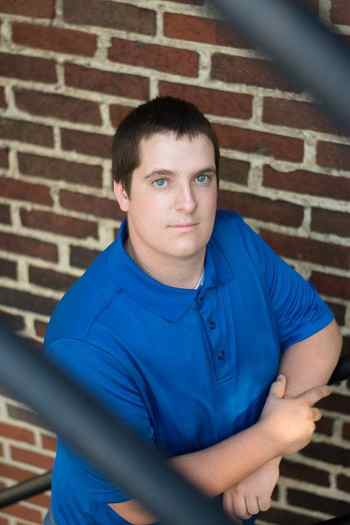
[241,220,333,350]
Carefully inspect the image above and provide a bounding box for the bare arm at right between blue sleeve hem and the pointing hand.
[279,321,342,396]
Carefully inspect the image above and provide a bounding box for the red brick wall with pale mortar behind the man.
[0,0,350,525]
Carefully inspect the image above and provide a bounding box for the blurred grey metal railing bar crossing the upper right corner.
[212,0,350,132]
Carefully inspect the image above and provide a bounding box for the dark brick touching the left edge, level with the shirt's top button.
[0,286,56,315]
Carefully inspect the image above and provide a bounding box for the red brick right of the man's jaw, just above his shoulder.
[219,191,304,228]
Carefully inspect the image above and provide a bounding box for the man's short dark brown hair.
[112,97,220,193]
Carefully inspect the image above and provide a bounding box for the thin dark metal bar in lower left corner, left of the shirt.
[0,472,51,509]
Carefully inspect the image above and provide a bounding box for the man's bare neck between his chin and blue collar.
[125,238,205,288]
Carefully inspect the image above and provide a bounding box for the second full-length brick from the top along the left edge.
[0,53,57,84]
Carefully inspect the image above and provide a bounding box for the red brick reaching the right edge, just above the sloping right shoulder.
[260,229,350,269]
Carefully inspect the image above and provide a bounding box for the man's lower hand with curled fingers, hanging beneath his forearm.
[223,458,280,520]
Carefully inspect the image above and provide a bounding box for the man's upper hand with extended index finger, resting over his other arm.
[258,375,331,456]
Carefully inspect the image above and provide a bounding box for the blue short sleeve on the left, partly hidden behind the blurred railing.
[45,338,154,503]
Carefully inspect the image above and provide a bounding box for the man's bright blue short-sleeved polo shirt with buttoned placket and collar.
[45,211,333,525]
